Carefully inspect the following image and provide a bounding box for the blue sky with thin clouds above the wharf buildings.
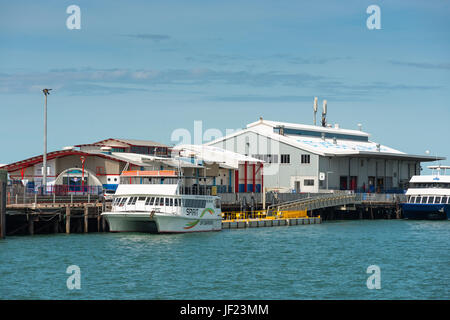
[0,0,450,168]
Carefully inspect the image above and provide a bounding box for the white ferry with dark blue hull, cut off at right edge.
[402,166,450,220]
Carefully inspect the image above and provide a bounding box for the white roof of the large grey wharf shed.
[206,120,445,161]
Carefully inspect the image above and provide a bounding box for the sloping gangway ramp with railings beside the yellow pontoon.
[267,194,360,214]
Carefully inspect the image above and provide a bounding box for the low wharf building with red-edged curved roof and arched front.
[0,138,263,195]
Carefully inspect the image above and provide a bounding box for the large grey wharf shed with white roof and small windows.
[206,118,445,193]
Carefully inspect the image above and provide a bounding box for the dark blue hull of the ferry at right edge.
[402,203,450,220]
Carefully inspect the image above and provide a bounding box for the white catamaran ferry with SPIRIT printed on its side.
[102,170,222,233]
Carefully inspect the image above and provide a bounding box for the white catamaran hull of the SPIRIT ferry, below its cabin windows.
[103,212,222,233]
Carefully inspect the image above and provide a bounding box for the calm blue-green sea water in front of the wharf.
[0,220,450,299]
